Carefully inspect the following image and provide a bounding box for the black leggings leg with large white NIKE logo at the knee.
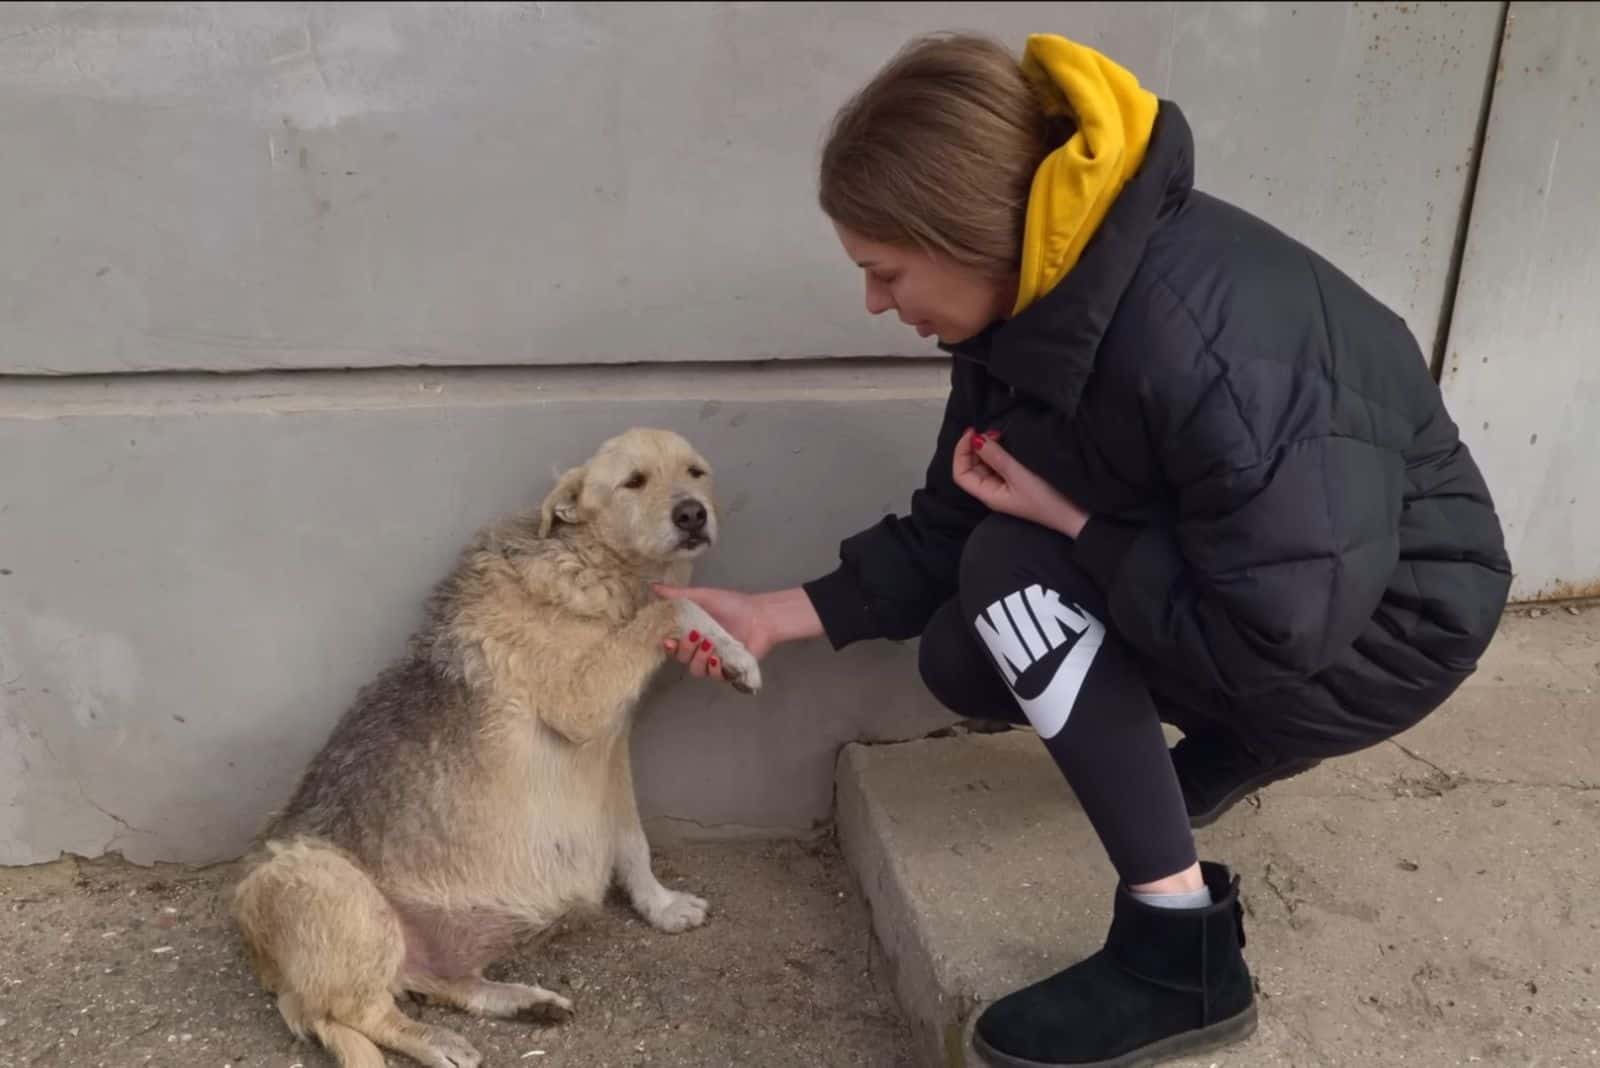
[920,515,1195,884]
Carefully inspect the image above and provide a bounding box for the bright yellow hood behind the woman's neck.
[1011,34,1157,315]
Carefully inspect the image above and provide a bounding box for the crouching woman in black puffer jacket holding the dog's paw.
[662,37,1510,1066]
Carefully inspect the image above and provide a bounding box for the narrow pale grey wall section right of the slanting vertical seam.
[1442,3,1600,600]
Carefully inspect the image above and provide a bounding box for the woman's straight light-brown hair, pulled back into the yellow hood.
[818,34,1072,277]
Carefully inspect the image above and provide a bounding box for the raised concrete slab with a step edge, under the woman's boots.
[837,608,1600,1068]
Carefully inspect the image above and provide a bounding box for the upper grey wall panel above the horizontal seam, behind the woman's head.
[0,3,1498,374]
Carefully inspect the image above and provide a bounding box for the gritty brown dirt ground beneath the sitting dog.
[0,839,912,1068]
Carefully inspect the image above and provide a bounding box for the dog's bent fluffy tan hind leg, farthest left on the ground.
[234,839,482,1068]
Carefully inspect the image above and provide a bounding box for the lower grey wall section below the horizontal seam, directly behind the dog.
[0,363,949,863]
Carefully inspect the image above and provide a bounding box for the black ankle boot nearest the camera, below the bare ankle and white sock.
[973,863,1256,1068]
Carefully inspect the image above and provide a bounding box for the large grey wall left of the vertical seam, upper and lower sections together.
[0,3,1523,863]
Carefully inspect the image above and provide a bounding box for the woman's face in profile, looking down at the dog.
[834,222,1016,345]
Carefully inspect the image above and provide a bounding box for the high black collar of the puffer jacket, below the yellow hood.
[942,101,1194,417]
